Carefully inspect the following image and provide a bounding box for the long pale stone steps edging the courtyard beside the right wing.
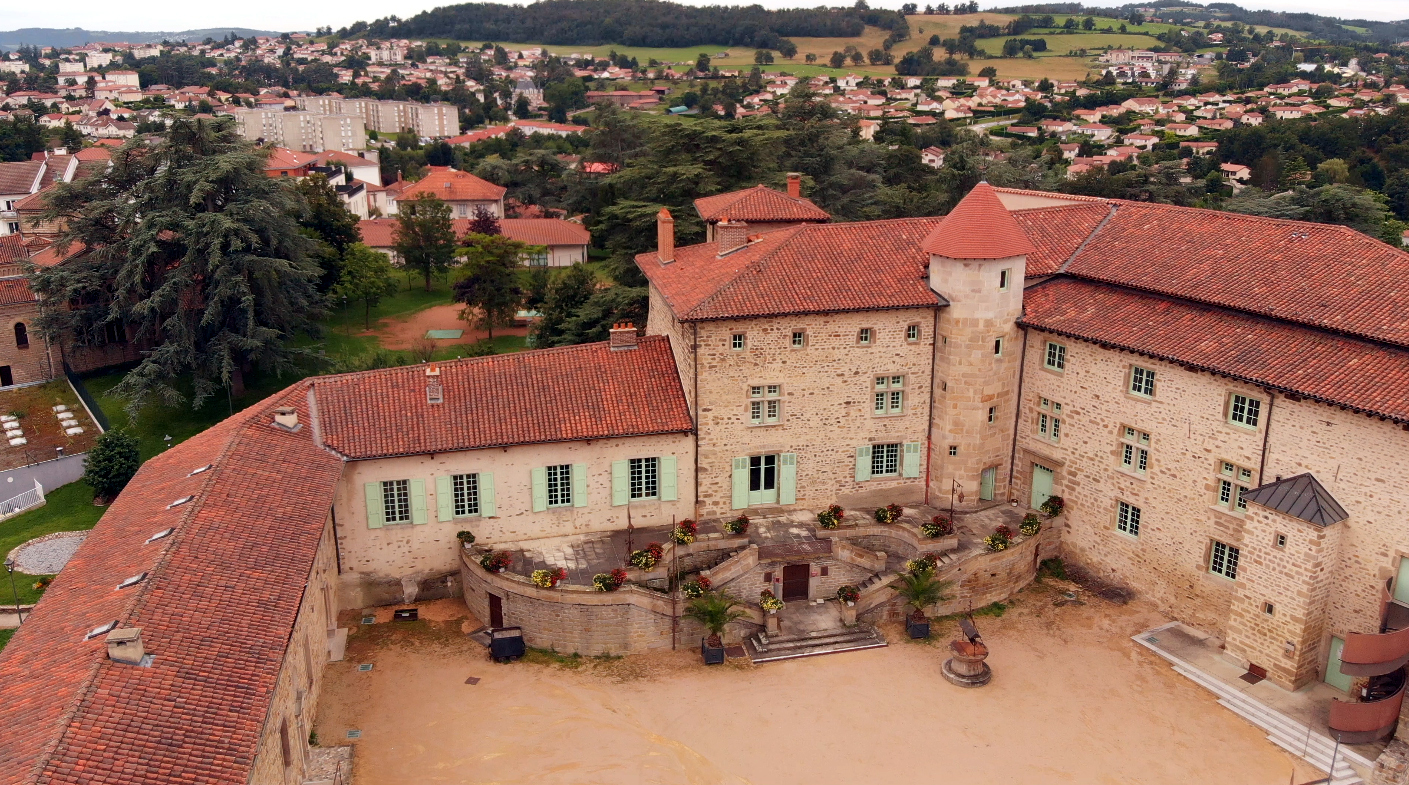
[1134,633,1374,785]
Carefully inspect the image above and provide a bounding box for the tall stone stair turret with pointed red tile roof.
[921,183,1034,507]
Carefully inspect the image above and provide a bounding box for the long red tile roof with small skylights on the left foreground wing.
[0,382,342,785]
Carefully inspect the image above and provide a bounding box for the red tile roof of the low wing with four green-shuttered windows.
[313,335,693,459]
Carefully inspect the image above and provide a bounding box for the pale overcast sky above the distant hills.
[0,0,1409,31]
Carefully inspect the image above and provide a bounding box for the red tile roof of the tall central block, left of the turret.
[635,218,944,321]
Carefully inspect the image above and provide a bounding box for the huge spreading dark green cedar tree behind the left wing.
[31,118,323,413]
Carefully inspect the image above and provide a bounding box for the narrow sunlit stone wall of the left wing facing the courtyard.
[249,519,338,785]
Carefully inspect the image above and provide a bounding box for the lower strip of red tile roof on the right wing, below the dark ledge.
[1022,278,1409,423]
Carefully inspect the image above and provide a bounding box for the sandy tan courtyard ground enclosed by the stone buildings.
[317,586,1316,785]
